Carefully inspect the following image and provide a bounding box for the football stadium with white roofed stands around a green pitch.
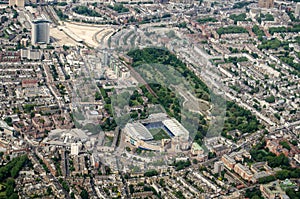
[124,113,189,152]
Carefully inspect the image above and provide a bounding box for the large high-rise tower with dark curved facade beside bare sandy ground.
[31,19,50,45]
